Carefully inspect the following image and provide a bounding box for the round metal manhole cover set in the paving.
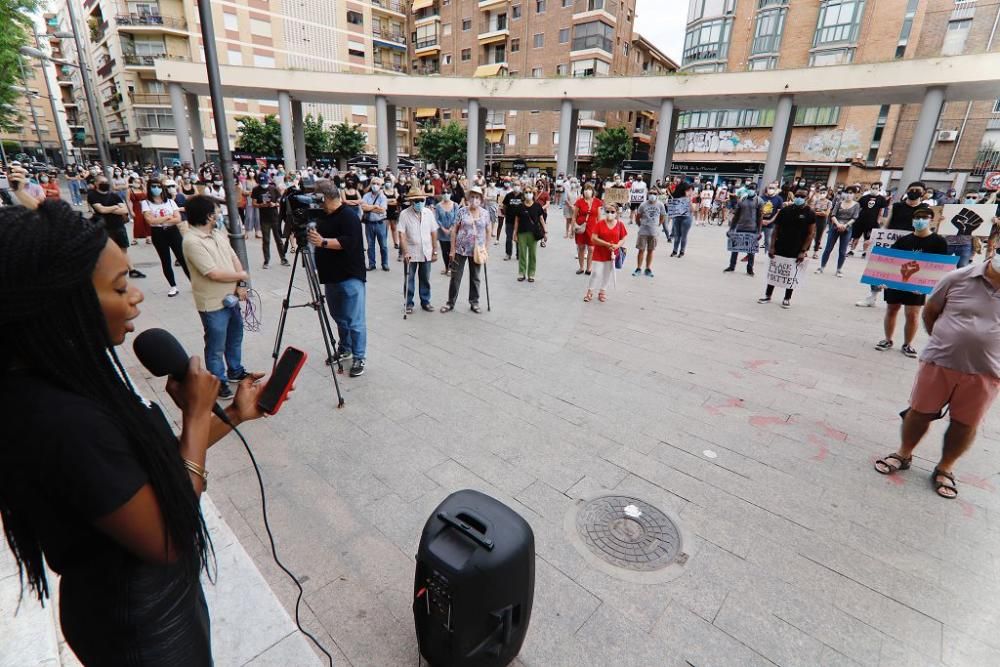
[576,496,681,572]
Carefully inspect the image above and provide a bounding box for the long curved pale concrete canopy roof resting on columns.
[156,53,1000,111]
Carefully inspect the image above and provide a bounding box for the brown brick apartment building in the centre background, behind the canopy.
[409,0,676,171]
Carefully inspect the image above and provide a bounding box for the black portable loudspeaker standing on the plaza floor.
[413,489,535,667]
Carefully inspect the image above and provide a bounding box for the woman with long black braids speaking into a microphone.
[0,190,272,667]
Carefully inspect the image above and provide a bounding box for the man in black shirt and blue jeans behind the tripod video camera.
[308,180,368,377]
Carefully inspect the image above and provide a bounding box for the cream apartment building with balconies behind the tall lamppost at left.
[51,0,411,163]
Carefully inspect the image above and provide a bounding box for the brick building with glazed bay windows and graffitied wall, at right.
[673,0,998,187]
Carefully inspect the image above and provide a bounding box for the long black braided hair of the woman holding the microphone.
[0,200,211,603]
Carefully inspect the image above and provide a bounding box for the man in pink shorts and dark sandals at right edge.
[875,255,1000,498]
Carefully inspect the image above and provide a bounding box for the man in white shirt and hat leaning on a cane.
[397,190,438,315]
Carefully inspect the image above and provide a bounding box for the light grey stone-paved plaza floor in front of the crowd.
[109,214,1000,667]
